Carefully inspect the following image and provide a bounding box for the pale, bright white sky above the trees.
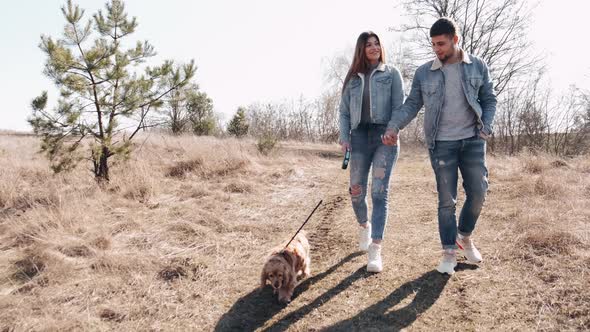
[0,0,590,131]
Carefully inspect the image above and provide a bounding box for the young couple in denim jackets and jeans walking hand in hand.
[340,18,496,275]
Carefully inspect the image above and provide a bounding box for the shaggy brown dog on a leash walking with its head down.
[260,232,311,303]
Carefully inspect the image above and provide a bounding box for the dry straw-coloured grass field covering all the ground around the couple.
[0,134,590,331]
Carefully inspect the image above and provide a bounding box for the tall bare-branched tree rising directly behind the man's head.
[396,0,542,95]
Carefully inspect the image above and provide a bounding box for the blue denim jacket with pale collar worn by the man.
[388,50,496,149]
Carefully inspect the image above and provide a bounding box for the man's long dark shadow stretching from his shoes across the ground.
[322,263,477,331]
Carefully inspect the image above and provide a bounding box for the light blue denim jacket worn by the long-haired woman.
[340,63,404,142]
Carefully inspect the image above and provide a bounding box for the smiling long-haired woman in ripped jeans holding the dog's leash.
[340,31,404,272]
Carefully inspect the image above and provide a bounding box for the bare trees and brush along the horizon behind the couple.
[222,0,590,155]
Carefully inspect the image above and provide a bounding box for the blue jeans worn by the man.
[429,136,488,249]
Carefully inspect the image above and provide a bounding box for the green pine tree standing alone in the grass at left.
[29,0,196,182]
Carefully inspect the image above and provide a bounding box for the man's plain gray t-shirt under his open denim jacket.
[436,62,477,141]
